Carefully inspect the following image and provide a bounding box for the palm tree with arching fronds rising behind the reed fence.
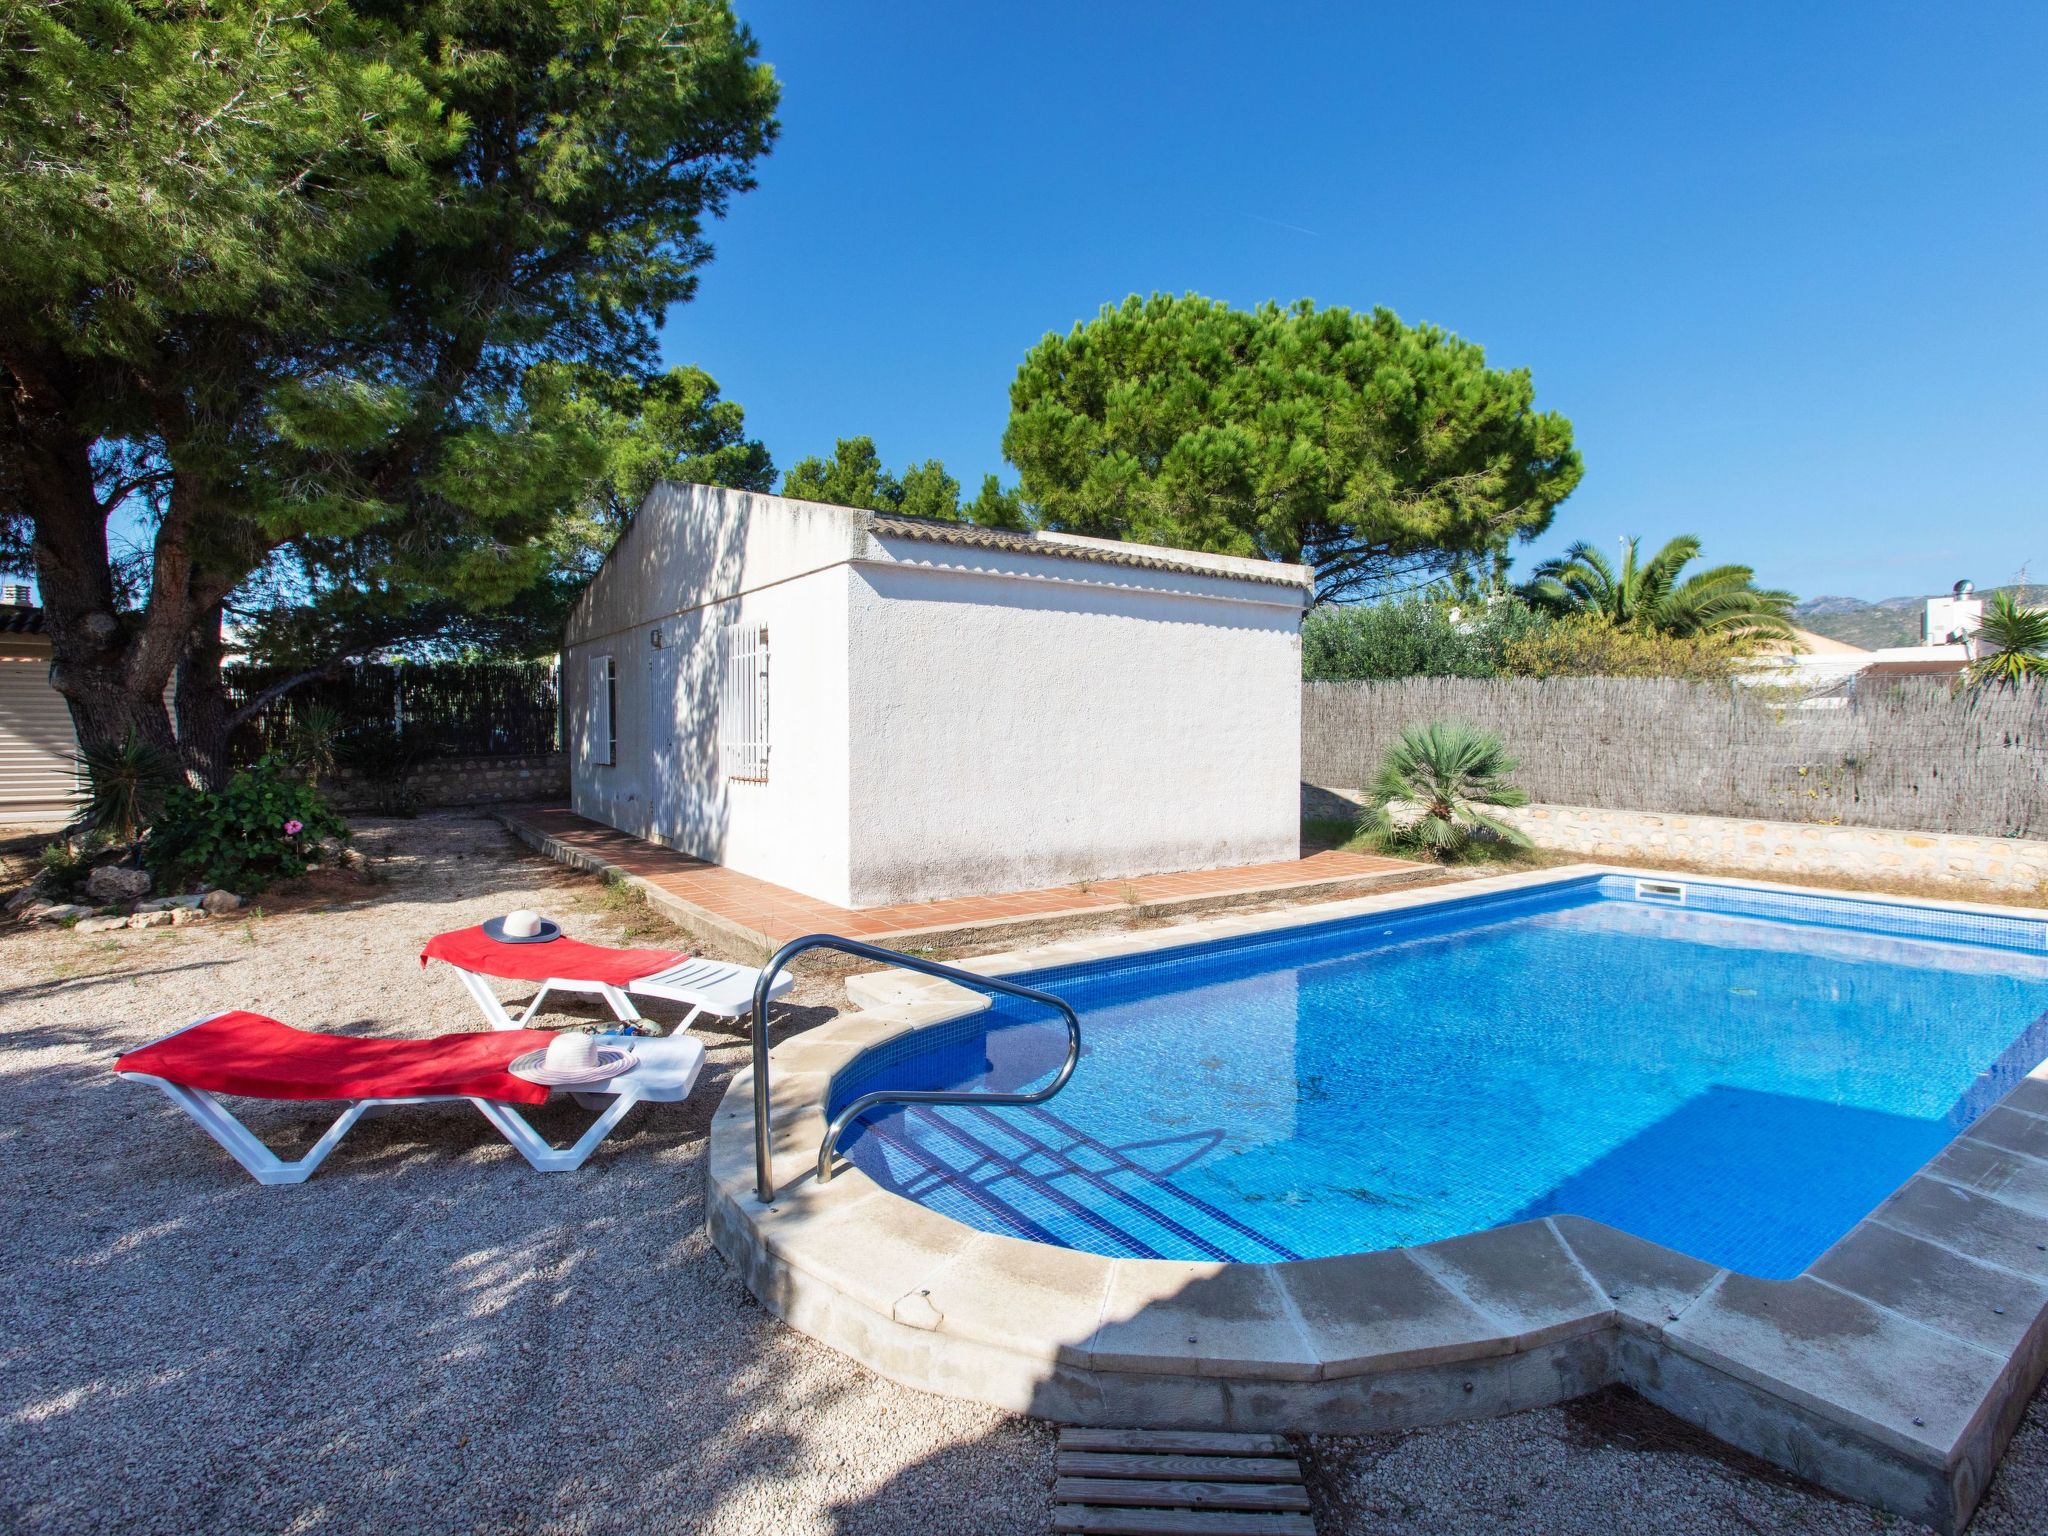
[1522,532,1792,639]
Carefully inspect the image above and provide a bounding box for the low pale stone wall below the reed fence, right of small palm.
[1497,805,2048,899]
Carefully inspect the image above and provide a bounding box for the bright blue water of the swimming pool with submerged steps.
[834,877,2048,1278]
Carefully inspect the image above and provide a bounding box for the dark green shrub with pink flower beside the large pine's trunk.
[143,758,348,897]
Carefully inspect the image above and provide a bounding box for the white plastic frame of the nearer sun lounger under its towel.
[121,1014,705,1184]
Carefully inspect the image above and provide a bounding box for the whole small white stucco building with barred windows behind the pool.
[563,483,1311,907]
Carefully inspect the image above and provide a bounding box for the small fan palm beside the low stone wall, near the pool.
[1360,721,1530,858]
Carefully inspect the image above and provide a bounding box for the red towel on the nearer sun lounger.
[115,1012,555,1104]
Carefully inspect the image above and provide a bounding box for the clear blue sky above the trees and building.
[664,0,2048,598]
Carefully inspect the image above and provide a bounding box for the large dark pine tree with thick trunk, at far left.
[0,0,778,770]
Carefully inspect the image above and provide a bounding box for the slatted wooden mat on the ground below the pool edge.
[1053,1430,1315,1536]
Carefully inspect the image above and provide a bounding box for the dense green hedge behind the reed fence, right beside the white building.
[1300,598,1544,682]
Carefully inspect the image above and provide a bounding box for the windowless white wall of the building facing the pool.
[848,539,1300,905]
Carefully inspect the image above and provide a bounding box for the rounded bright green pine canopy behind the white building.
[1004,295,1581,598]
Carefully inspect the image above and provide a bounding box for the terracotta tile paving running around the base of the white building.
[498,805,1423,944]
